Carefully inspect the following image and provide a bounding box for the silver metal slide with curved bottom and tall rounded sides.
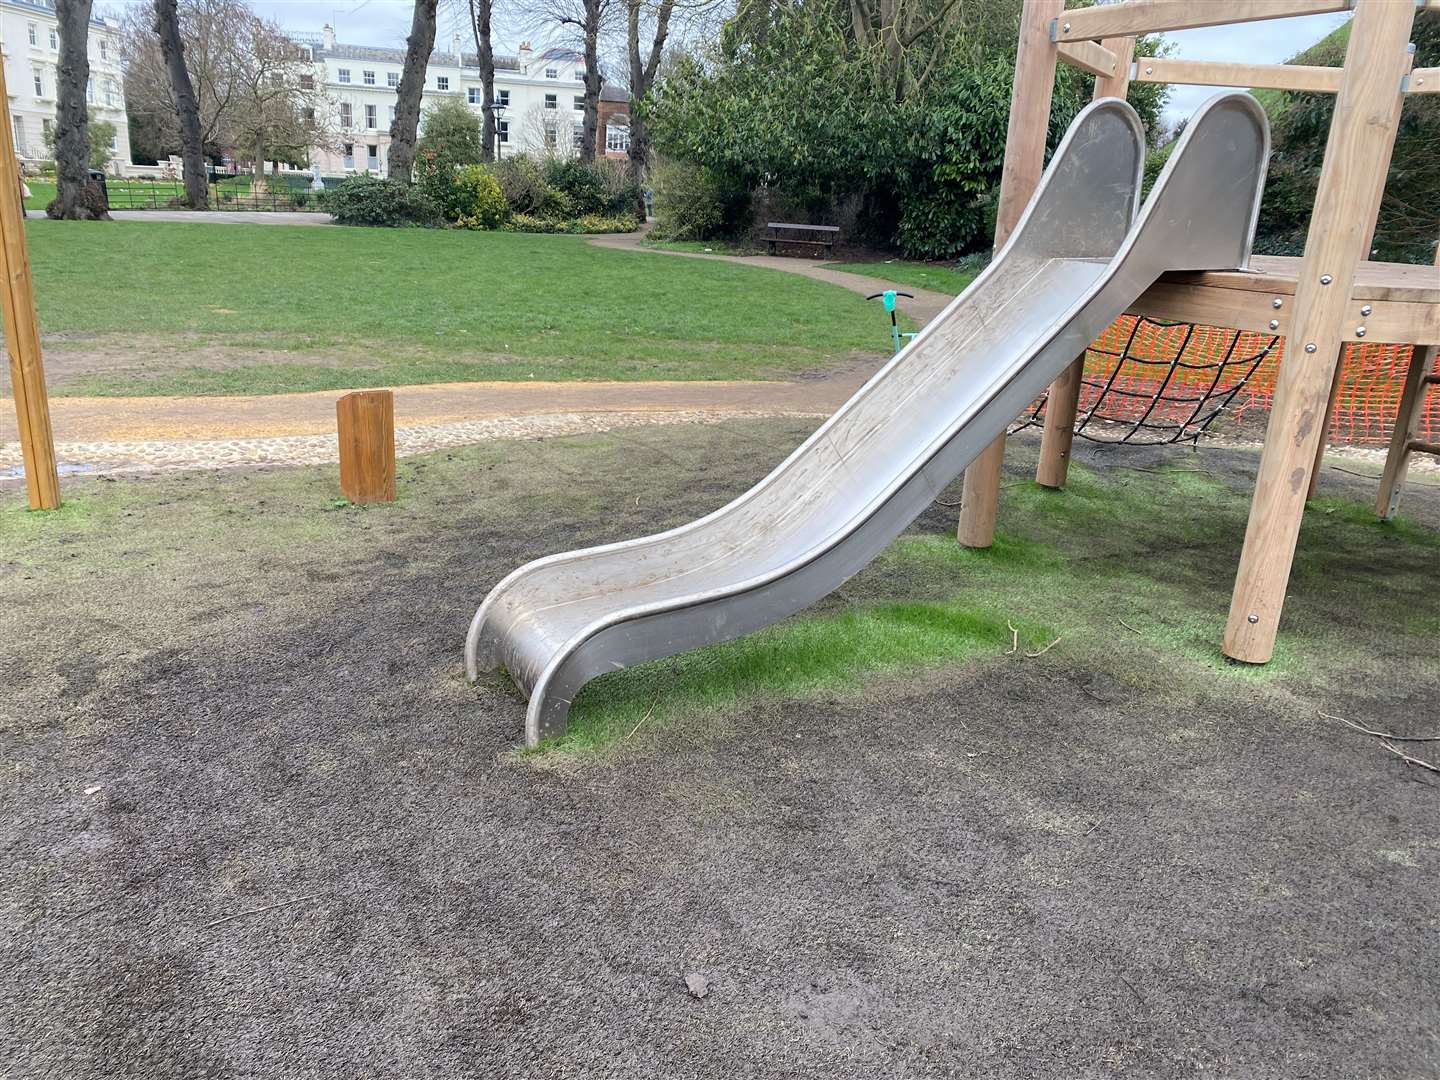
[465,94,1270,746]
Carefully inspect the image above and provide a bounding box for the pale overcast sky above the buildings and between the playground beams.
[106,0,1349,124]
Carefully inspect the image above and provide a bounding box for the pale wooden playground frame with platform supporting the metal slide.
[958,0,1440,664]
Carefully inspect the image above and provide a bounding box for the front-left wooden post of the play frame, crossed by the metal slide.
[955,0,1064,547]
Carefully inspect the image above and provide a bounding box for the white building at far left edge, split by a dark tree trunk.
[0,0,130,173]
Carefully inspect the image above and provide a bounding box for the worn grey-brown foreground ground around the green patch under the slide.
[0,422,1440,1080]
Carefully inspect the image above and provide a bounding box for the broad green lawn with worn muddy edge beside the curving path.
[27,220,884,395]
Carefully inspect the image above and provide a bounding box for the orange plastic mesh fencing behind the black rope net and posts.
[1015,315,1440,445]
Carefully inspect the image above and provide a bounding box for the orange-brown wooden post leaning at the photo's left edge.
[0,63,60,510]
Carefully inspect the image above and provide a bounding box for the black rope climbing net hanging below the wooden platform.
[1011,315,1280,446]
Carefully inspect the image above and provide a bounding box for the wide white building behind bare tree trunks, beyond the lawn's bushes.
[297,26,629,176]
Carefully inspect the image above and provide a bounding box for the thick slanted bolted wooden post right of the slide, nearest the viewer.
[1224,0,1416,664]
